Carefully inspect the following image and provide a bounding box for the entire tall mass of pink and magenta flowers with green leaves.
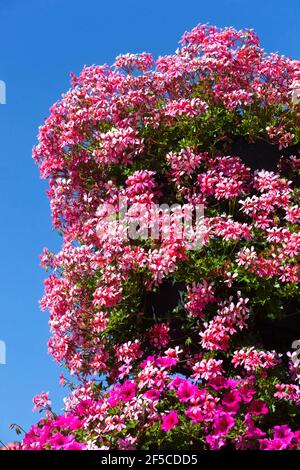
[20,25,300,450]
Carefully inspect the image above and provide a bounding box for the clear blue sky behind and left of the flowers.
[0,0,300,441]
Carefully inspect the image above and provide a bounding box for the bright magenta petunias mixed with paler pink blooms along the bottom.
[21,350,300,450]
